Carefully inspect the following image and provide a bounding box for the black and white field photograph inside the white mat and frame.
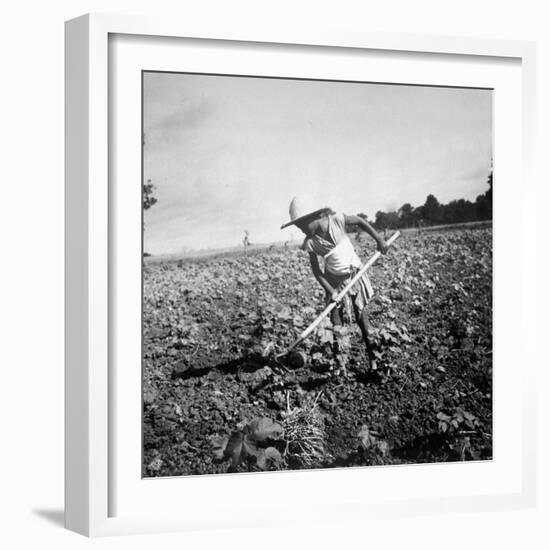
[141,71,494,477]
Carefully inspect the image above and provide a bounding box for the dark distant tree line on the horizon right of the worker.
[349,171,493,232]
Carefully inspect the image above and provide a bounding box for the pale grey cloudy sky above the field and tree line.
[143,73,492,254]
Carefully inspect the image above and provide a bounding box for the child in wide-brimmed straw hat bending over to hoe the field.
[281,197,388,369]
